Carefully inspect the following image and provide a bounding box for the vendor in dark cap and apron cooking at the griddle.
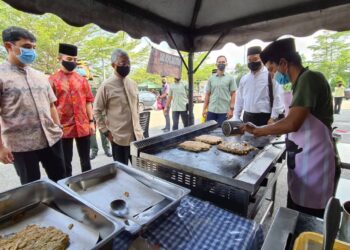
[242,38,340,218]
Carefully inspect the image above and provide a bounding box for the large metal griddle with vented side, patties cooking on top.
[131,121,285,217]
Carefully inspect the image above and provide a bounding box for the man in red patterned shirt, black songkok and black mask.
[49,43,95,176]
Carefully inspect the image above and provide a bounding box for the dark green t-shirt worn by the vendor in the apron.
[291,69,333,128]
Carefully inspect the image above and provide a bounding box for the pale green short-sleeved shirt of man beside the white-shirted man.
[206,74,237,114]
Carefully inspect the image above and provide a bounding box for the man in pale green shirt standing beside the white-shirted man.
[202,56,237,126]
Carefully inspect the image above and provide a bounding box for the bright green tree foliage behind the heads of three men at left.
[0,2,147,76]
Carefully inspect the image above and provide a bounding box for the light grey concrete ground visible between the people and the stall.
[0,101,350,234]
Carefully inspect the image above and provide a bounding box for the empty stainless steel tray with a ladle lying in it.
[59,162,189,233]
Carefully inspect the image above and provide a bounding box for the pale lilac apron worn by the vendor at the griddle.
[286,114,335,209]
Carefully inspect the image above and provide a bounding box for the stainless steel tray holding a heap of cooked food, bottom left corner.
[0,180,124,249]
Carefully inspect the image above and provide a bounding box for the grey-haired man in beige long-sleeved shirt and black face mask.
[94,49,143,165]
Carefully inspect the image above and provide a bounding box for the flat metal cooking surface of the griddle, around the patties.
[145,128,270,178]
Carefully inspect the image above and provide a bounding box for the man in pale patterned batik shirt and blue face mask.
[0,27,66,184]
